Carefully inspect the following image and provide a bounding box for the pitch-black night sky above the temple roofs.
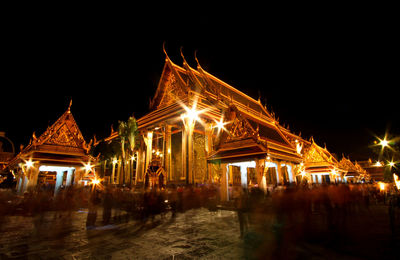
[0,7,400,159]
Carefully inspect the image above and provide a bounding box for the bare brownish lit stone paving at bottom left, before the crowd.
[0,209,242,259]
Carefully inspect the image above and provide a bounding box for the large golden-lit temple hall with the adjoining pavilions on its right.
[108,49,368,199]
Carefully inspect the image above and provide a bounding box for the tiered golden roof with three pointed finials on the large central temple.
[138,51,301,162]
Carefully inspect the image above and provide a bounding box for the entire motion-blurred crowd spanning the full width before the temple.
[0,184,400,252]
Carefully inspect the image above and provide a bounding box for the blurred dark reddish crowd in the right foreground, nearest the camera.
[234,184,400,259]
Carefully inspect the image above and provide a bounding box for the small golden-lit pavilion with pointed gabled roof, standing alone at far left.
[8,102,97,194]
